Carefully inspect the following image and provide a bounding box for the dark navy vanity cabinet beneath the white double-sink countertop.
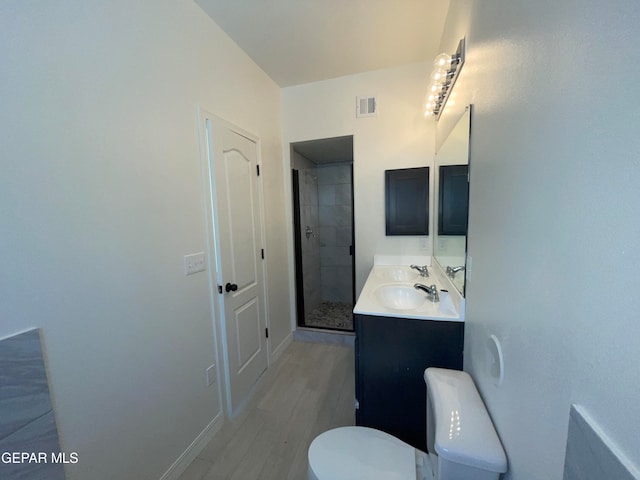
[354,314,464,451]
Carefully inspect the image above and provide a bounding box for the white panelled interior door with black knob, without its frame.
[207,119,268,414]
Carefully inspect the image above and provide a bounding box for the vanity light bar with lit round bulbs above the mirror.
[424,38,465,120]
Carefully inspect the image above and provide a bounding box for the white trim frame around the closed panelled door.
[197,106,271,418]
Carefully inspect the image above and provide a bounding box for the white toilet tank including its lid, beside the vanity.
[424,368,507,480]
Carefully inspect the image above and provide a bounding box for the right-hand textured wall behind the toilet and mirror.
[438,0,640,480]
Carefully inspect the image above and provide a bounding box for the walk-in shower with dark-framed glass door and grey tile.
[291,136,354,330]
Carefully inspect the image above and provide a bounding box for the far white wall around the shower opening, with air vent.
[282,62,434,294]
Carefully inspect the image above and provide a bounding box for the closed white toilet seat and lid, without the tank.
[309,427,416,480]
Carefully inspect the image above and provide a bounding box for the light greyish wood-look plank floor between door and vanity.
[179,341,355,480]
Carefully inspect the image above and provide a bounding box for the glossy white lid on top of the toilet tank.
[424,368,507,473]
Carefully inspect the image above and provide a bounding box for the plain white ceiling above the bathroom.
[196,0,449,87]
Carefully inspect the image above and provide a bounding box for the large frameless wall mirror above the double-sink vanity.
[434,106,471,295]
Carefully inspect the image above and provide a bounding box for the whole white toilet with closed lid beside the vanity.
[309,368,507,480]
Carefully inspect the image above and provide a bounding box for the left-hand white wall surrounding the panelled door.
[0,0,290,480]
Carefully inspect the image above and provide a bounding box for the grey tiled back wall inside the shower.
[317,163,353,303]
